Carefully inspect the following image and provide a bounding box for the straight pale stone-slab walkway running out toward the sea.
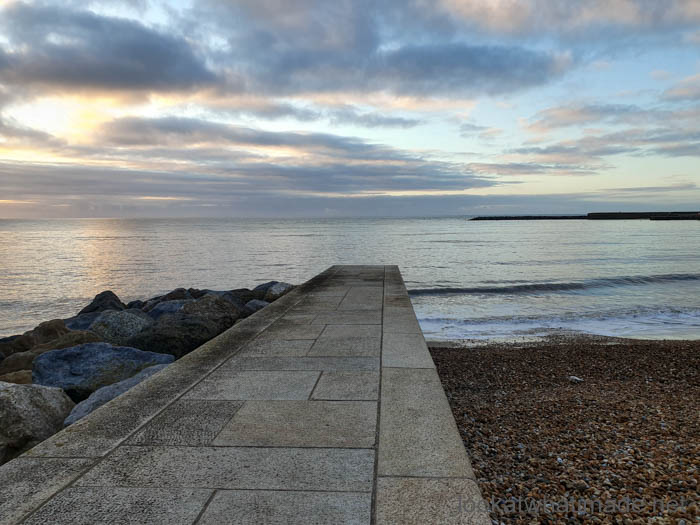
[0,266,490,525]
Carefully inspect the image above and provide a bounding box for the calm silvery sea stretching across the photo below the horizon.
[0,218,700,339]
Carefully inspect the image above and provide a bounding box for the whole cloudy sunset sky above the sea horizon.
[0,0,700,218]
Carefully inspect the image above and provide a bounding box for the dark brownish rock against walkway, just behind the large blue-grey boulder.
[126,312,221,358]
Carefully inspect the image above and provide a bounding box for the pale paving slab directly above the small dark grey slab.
[185,368,320,400]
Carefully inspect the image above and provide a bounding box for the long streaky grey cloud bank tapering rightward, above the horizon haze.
[0,117,486,199]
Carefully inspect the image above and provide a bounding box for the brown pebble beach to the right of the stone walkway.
[430,334,700,524]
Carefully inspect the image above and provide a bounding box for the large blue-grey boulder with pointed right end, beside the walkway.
[32,343,174,401]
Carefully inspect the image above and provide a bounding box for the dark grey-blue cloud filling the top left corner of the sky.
[0,3,220,92]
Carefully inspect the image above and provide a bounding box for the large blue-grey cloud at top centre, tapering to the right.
[187,0,574,96]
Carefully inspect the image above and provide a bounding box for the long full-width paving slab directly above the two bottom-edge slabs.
[75,445,374,492]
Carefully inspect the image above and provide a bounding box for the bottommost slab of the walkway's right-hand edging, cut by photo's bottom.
[376,477,491,525]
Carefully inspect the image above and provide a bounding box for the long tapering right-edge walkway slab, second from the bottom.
[378,368,474,478]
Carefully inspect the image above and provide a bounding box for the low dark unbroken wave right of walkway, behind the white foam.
[408,273,700,296]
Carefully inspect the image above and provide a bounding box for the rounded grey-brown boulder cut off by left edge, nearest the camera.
[0,383,73,463]
